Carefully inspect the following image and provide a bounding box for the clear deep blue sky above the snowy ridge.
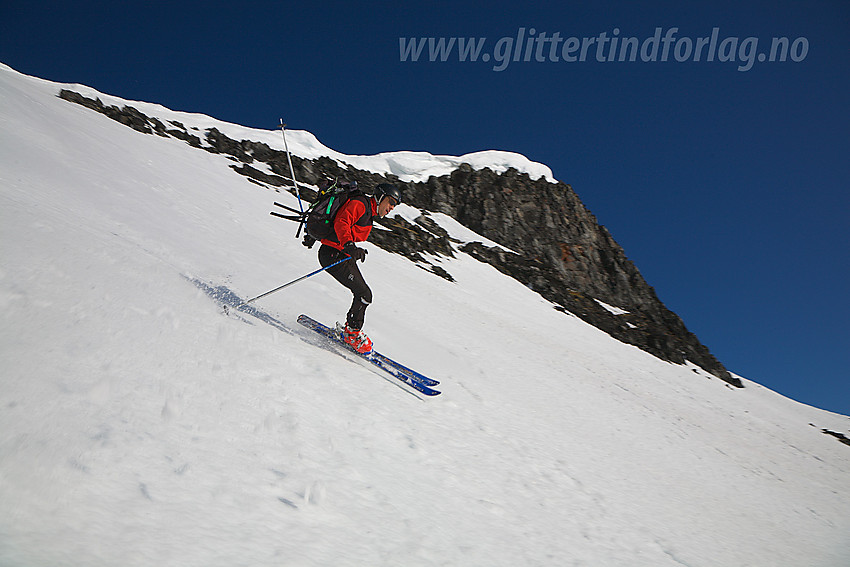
[0,0,850,415]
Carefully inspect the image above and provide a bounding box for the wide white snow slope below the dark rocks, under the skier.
[0,68,850,566]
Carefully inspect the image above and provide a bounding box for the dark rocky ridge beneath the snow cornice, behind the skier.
[59,90,743,387]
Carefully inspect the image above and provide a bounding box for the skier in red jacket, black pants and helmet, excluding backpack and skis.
[319,183,401,354]
